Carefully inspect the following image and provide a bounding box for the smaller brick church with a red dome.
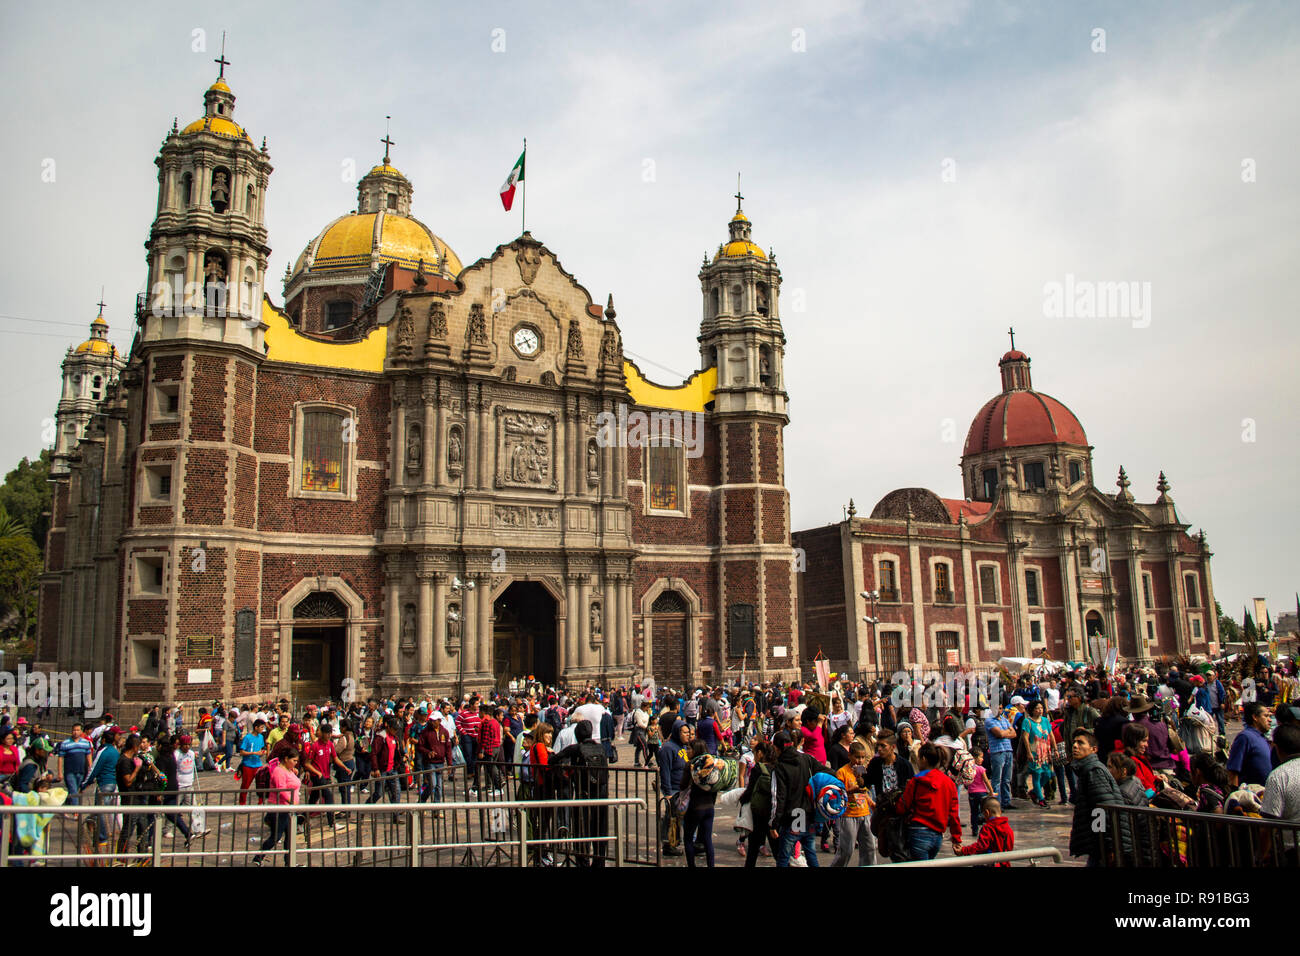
[793,338,1218,674]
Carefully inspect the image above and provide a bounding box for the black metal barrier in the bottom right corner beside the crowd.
[1104,804,1300,869]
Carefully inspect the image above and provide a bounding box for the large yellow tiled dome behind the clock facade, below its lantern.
[294,212,464,276]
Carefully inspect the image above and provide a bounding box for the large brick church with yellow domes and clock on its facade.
[36,64,802,705]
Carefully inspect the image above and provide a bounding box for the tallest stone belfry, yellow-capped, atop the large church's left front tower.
[137,53,272,352]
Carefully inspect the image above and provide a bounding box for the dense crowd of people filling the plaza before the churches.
[0,662,1300,866]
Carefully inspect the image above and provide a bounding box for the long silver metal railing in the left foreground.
[0,799,645,866]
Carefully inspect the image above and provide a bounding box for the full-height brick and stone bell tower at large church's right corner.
[699,177,801,679]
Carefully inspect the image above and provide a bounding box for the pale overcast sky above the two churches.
[0,0,1300,629]
